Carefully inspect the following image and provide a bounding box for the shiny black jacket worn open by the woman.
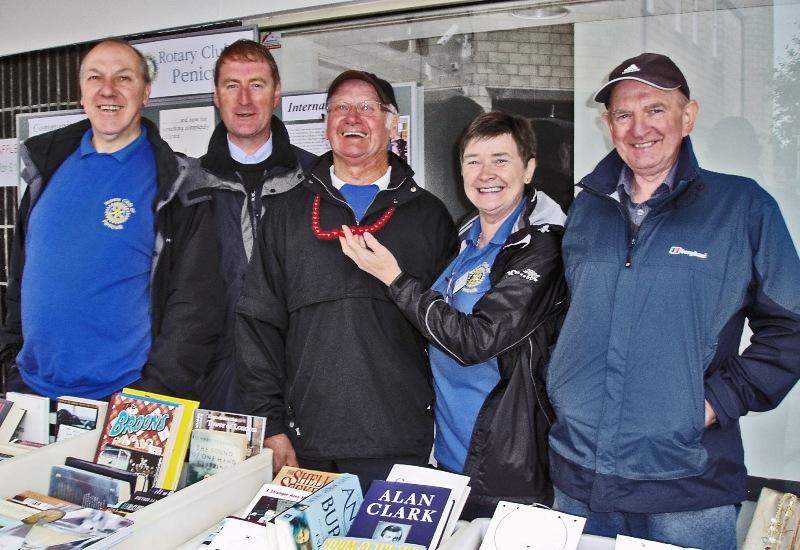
[389,192,567,519]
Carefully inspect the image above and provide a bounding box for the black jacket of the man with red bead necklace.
[236,153,457,460]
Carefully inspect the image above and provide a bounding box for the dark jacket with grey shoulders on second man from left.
[200,121,317,412]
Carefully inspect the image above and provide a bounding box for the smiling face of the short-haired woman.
[461,134,536,223]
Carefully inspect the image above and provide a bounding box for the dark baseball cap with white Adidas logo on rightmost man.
[594,53,690,107]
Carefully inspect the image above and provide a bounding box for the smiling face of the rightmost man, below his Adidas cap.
[603,80,698,181]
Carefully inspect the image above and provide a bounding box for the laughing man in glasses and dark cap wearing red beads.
[236,71,456,487]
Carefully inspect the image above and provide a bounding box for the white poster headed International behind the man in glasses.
[275,82,424,182]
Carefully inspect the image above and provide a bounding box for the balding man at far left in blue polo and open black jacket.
[0,39,221,398]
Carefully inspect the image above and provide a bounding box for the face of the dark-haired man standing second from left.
[214,58,281,154]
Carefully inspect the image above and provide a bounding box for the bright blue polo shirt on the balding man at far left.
[17,127,156,398]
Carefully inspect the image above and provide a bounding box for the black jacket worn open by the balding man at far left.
[0,119,222,398]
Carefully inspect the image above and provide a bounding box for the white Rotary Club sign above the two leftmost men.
[131,26,258,100]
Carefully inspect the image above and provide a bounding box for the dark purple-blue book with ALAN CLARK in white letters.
[347,479,450,550]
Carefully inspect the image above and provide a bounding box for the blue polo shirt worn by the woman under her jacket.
[428,201,524,472]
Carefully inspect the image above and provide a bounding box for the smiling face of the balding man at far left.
[80,42,150,153]
